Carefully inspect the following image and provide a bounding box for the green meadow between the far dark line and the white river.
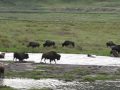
[0,13,120,55]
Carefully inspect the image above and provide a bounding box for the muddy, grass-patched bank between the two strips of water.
[2,62,120,82]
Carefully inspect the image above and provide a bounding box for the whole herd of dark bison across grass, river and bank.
[0,40,120,77]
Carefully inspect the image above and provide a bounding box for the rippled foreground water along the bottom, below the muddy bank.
[0,78,120,90]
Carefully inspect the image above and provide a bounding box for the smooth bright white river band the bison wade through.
[0,53,120,66]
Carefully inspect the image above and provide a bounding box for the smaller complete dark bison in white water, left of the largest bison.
[13,52,29,62]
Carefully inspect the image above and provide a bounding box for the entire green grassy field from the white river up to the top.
[0,0,120,55]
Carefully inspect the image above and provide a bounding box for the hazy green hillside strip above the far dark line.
[0,0,120,12]
